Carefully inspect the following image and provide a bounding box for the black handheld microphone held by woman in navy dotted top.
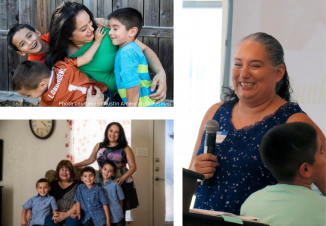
[202,119,219,186]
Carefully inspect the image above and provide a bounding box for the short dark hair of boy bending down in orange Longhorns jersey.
[12,60,51,91]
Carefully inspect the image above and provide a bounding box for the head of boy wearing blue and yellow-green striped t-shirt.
[108,8,143,47]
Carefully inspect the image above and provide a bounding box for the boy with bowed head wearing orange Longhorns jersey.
[12,58,113,107]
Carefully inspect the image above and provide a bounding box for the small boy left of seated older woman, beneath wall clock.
[21,178,58,226]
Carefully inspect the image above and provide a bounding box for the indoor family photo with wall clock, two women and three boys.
[0,119,174,226]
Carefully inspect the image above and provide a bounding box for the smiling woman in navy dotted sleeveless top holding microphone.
[190,32,326,214]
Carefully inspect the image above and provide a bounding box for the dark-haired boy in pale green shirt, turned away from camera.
[241,122,326,226]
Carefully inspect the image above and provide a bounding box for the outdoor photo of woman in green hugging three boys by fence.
[0,0,173,107]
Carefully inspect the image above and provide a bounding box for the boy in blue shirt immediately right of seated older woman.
[74,166,110,226]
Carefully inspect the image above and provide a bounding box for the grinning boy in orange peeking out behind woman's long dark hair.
[7,24,49,62]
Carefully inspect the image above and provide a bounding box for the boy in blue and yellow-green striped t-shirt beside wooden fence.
[108,8,166,107]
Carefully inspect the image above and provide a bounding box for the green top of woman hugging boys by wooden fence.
[68,27,118,95]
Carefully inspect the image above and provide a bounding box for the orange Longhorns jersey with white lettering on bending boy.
[41,58,107,107]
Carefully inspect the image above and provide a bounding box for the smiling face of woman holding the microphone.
[232,40,284,101]
